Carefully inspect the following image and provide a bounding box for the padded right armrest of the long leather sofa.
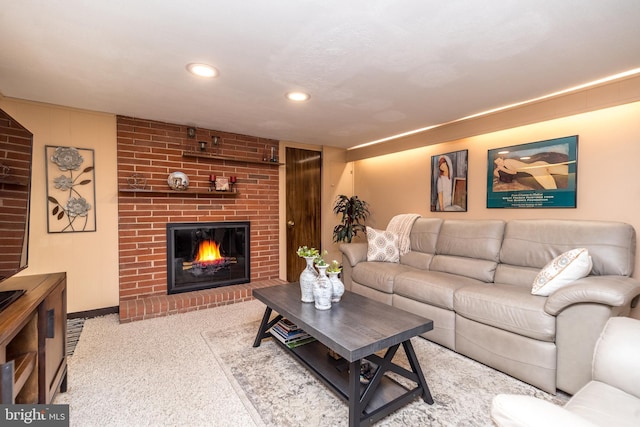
[544,276,640,316]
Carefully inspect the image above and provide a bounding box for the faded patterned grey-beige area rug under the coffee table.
[203,322,568,426]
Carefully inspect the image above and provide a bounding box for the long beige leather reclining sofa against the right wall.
[340,218,640,394]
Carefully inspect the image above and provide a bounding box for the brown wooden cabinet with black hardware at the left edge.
[0,273,67,404]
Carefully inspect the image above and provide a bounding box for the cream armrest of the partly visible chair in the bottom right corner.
[491,394,595,427]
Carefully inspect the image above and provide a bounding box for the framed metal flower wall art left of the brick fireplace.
[45,145,96,233]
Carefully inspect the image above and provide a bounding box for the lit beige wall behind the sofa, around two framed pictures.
[355,102,640,317]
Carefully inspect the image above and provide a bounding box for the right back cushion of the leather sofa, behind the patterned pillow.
[500,219,636,285]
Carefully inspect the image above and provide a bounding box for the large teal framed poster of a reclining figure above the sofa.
[487,135,578,208]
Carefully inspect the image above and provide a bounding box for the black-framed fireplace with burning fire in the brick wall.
[167,221,250,294]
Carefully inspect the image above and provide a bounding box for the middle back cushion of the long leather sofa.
[429,220,505,282]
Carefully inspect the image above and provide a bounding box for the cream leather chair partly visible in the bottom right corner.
[491,317,640,427]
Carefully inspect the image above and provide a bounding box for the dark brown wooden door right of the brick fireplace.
[285,147,322,282]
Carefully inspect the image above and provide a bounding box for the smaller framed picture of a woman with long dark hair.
[431,150,468,212]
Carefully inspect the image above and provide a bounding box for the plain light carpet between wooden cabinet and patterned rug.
[54,301,264,427]
